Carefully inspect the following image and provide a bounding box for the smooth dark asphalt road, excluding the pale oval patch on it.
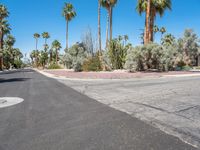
[0,70,198,150]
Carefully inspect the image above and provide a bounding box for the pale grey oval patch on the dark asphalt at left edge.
[0,97,24,108]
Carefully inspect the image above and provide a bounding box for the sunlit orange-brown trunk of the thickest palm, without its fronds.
[144,0,151,44]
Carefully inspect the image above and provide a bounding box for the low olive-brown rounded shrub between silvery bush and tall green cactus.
[82,55,102,71]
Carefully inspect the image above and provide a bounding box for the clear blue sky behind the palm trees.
[1,0,200,53]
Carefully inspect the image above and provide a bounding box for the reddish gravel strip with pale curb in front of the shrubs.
[35,69,200,79]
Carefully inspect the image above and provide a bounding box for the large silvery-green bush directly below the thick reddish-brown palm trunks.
[125,43,181,71]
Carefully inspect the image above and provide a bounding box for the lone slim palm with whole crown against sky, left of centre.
[63,3,76,52]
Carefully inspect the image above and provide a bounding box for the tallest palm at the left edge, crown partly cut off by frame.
[0,4,9,70]
